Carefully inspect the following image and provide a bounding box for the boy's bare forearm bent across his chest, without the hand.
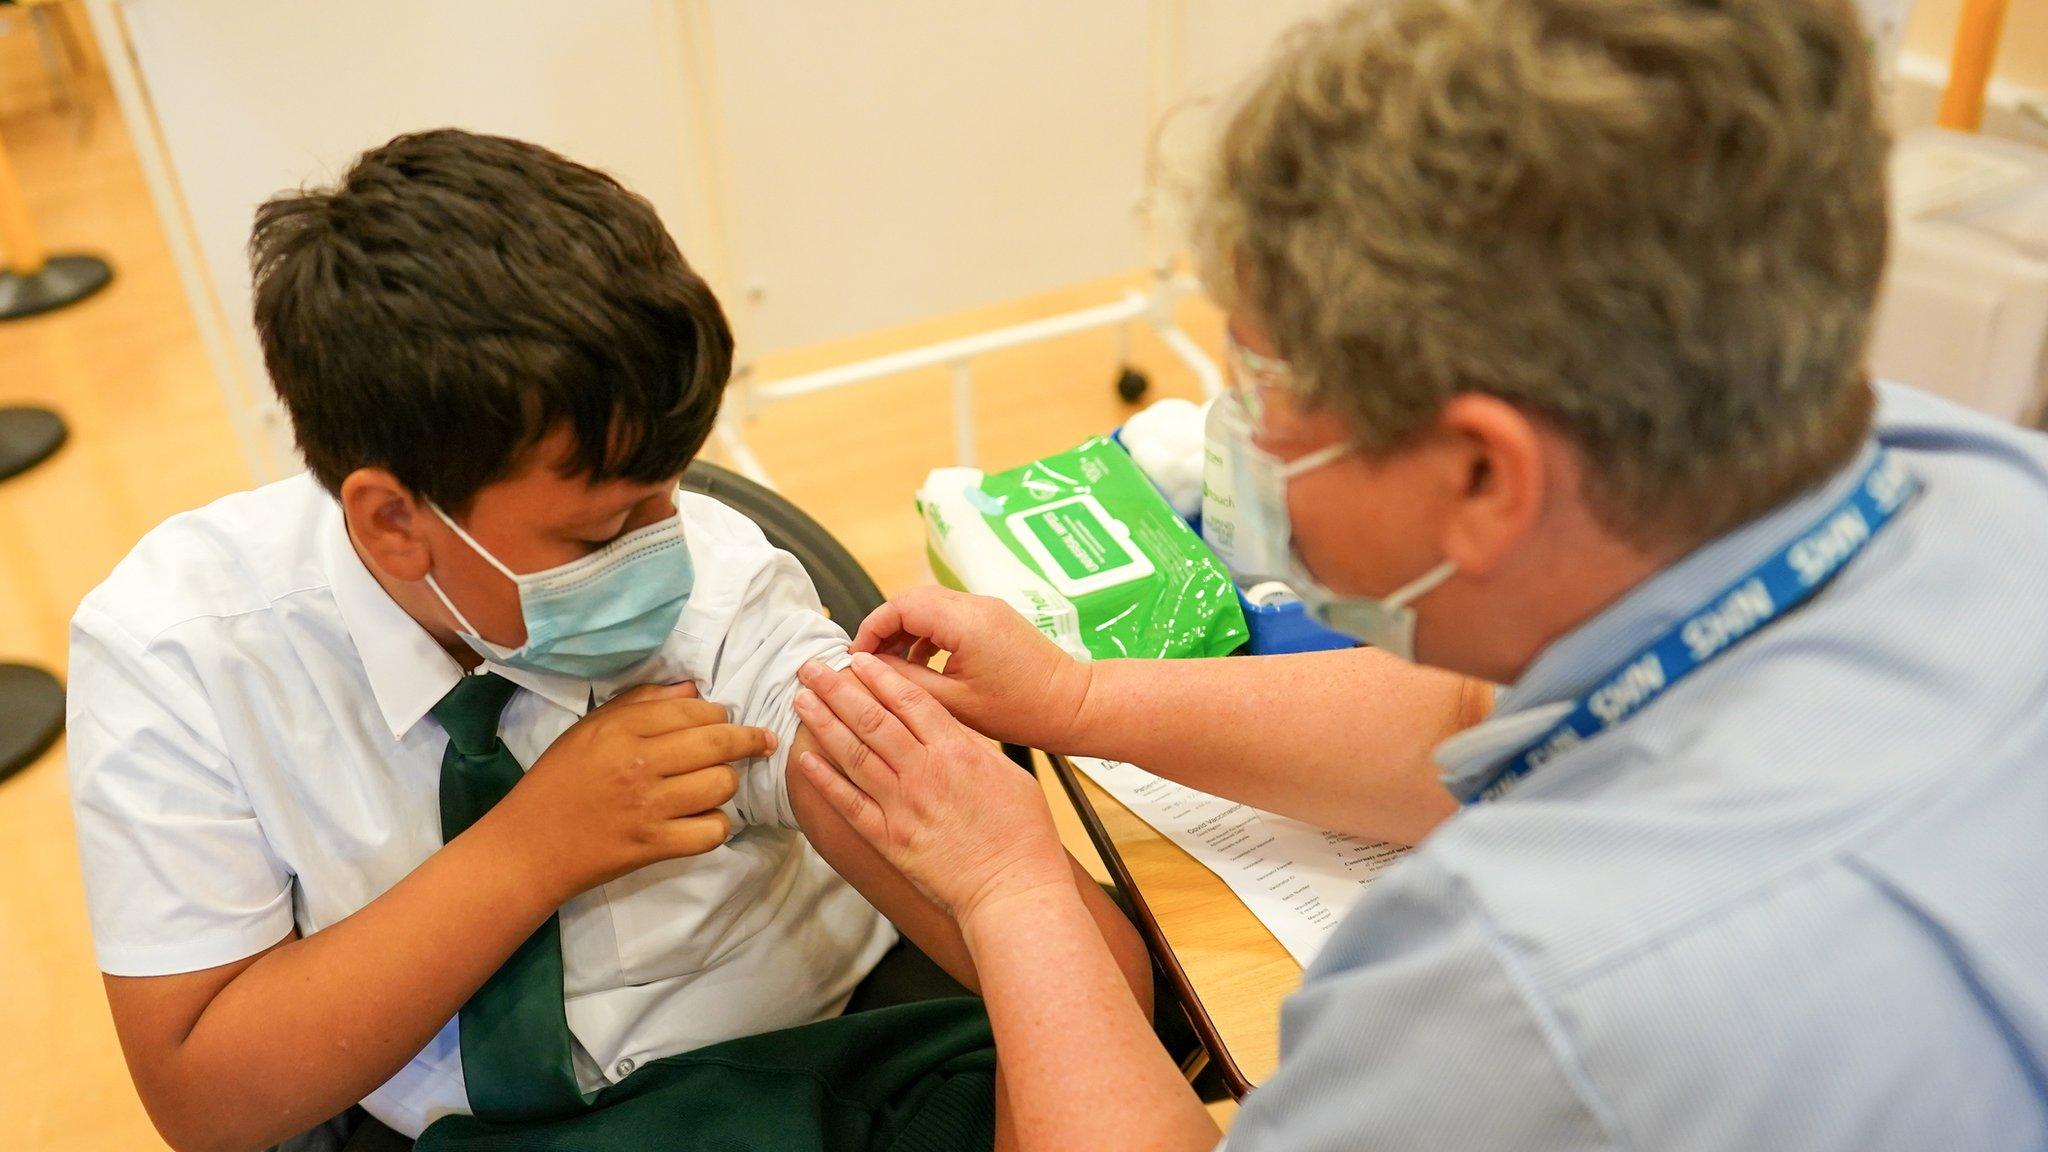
[123,818,567,1150]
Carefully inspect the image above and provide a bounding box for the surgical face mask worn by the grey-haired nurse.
[1231,422,1458,660]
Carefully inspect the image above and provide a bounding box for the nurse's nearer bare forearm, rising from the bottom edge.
[963,883,1221,1152]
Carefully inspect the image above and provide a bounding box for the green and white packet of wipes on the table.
[918,437,1249,660]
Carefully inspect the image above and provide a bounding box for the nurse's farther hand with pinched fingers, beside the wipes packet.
[854,586,1090,752]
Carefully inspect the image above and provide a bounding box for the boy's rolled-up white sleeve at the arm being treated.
[688,523,848,828]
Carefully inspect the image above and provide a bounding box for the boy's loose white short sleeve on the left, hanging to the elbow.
[68,607,293,976]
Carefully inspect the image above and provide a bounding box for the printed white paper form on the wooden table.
[1073,756,1407,968]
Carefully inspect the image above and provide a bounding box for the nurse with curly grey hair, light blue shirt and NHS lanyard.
[782,0,2048,1152]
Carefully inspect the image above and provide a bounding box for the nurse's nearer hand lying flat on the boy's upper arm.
[797,651,1073,924]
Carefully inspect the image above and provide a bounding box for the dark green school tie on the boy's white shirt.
[434,672,584,1121]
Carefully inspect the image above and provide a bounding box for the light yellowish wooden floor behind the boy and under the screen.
[0,71,1219,1152]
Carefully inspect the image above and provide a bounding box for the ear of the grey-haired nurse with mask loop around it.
[1436,394,1559,576]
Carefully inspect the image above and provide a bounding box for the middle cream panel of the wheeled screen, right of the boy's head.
[711,0,1145,348]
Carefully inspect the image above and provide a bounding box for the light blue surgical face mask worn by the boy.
[426,487,696,681]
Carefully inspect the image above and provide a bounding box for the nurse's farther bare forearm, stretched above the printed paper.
[1065,650,1493,845]
